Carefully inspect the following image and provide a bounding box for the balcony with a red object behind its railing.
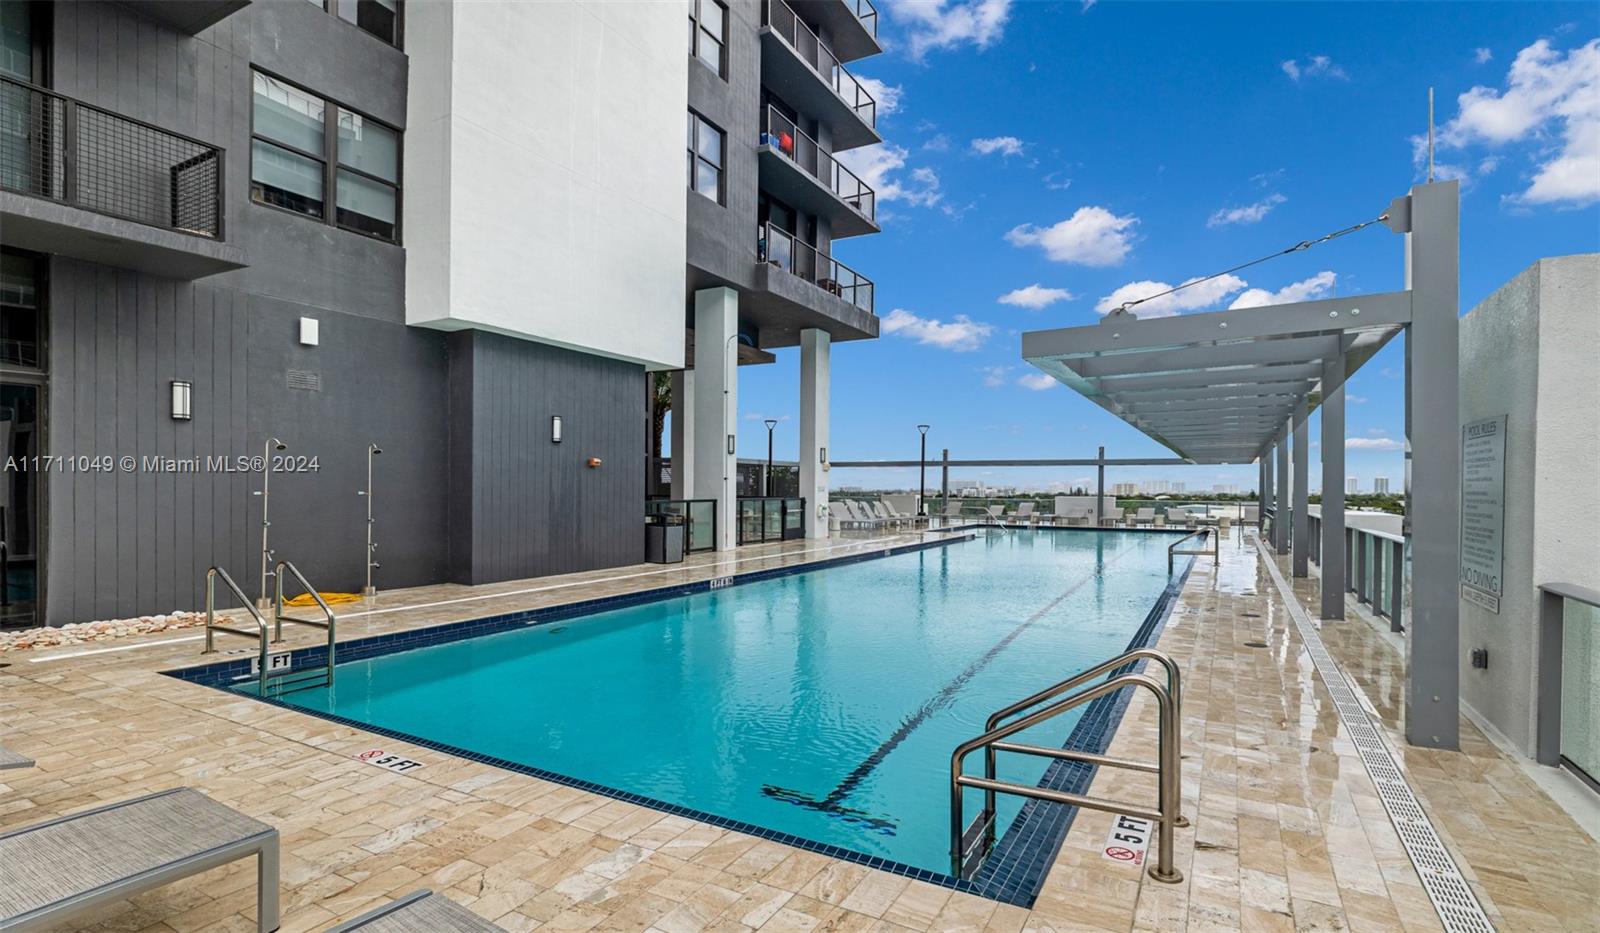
[757,106,878,240]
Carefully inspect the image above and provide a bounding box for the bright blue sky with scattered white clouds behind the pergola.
[739,0,1600,488]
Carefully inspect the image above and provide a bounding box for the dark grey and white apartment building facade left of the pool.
[0,0,877,626]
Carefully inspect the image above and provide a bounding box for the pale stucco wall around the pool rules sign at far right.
[1461,254,1600,755]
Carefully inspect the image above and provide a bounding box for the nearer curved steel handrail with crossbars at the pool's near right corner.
[950,674,1182,883]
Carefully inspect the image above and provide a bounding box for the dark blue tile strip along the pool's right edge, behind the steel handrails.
[963,557,1197,907]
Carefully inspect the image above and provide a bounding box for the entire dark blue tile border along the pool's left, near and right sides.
[163,535,1194,907]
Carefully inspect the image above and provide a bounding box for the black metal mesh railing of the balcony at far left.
[0,77,222,238]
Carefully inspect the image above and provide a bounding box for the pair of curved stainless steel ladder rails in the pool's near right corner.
[950,648,1189,883]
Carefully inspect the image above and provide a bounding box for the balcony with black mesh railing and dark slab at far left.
[0,78,245,278]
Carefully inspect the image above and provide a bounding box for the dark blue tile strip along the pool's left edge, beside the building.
[162,533,976,691]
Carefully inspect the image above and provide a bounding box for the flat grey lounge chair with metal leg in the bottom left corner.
[0,787,278,933]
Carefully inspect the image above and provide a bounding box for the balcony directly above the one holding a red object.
[762,0,883,152]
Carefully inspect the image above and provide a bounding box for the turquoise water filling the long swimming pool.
[265,531,1176,872]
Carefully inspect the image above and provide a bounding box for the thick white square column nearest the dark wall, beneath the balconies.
[691,286,739,551]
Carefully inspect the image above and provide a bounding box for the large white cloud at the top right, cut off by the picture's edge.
[1418,38,1600,206]
